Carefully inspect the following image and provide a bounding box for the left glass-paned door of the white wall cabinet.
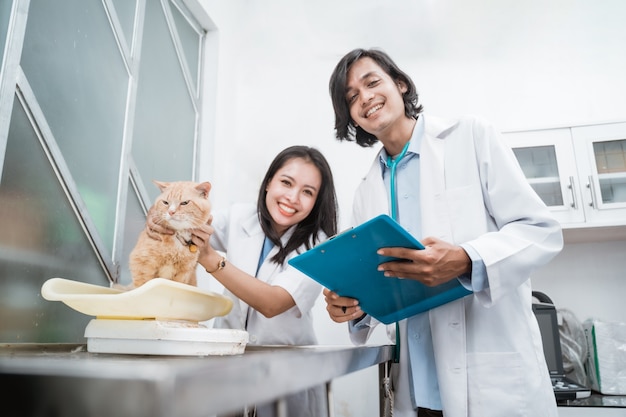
[504,128,585,225]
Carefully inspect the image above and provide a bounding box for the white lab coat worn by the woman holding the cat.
[211,204,328,417]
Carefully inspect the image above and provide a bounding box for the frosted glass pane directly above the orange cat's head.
[132,1,196,199]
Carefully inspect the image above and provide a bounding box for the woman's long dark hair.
[257,146,337,264]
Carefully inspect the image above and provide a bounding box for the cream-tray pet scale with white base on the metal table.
[41,278,248,356]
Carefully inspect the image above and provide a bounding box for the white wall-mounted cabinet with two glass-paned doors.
[504,122,626,237]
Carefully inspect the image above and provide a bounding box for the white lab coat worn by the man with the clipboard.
[352,115,563,417]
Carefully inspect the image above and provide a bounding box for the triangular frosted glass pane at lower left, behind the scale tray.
[0,96,108,343]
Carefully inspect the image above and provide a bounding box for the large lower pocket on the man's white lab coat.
[467,352,528,417]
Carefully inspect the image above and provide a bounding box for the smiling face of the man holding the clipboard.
[346,57,407,140]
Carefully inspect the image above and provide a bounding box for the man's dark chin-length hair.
[329,49,423,147]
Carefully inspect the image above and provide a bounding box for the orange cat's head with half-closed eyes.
[154,181,211,230]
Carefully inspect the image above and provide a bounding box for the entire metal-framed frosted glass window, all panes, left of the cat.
[0,0,210,343]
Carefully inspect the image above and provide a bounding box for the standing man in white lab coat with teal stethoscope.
[324,49,563,417]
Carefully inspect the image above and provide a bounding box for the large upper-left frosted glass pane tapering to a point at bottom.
[21,0,127,249]
